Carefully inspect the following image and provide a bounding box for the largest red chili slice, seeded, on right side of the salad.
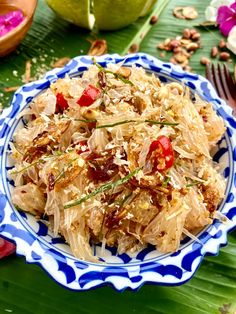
[147,135,174,172]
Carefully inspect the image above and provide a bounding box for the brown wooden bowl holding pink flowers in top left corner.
[0,0,38,57]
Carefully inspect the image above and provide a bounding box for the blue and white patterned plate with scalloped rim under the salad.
[0,53,236,291]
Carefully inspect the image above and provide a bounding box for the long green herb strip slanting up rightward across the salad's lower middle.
[64,168,141,209]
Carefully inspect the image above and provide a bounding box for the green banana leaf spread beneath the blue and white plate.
[0,0,236,314]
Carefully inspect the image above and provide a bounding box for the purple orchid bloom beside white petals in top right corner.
[216,1,236,36]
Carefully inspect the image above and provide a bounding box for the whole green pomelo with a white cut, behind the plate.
[46,0,156,30]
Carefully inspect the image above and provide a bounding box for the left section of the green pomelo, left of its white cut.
[46,0,94,29]
